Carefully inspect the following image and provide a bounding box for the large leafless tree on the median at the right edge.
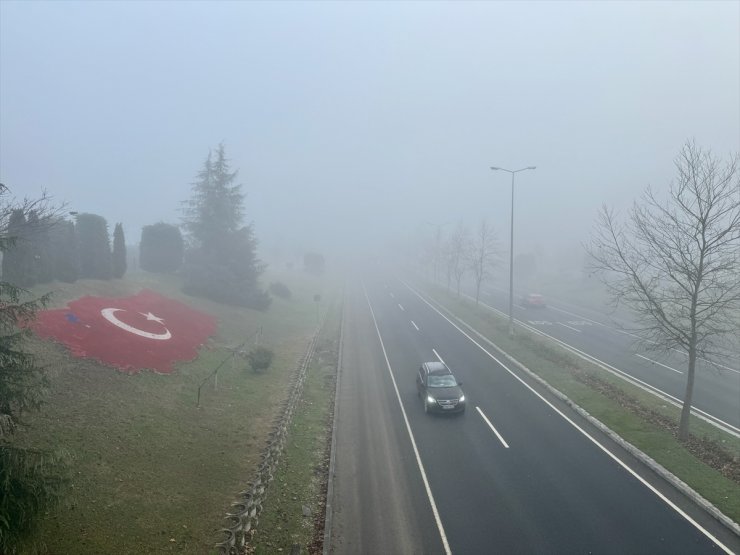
[587,141,740,440]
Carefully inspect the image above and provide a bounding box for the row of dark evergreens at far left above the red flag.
[2,208,126,287]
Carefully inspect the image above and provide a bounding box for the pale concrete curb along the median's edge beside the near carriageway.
[422,299,740,537]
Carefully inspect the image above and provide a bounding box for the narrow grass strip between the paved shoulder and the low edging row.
[252,299,342,554]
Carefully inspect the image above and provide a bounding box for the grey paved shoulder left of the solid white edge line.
[329,284,444,555]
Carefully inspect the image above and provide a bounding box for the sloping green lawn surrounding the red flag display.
[18,271,334,554]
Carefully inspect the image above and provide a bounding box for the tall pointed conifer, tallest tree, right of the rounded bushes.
[183,144,270,310]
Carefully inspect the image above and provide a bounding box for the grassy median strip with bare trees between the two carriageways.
[421,286,740,522]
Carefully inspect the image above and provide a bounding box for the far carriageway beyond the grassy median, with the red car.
[482,287,740,433]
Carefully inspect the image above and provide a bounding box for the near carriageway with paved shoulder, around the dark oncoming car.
[329,280,740,554]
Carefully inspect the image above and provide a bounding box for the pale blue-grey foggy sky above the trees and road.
[0,0,740,262]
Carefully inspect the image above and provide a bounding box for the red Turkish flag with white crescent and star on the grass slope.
[33,289,216,374]
